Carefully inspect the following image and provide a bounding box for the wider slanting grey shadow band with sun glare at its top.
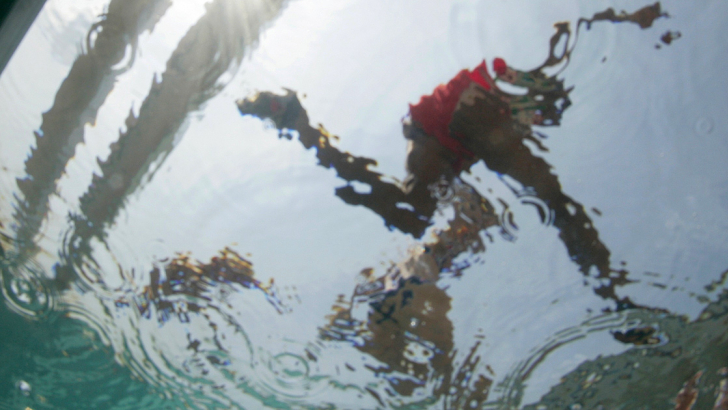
[38,0,283,288]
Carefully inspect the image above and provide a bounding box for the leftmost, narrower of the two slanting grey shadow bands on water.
[15,0,171,259]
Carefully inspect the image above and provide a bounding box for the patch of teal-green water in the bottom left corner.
[0,303,164,410]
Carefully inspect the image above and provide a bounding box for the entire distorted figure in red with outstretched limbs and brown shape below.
[238,4,663,408]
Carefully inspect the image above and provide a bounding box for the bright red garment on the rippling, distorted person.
[410,61,492,162]
